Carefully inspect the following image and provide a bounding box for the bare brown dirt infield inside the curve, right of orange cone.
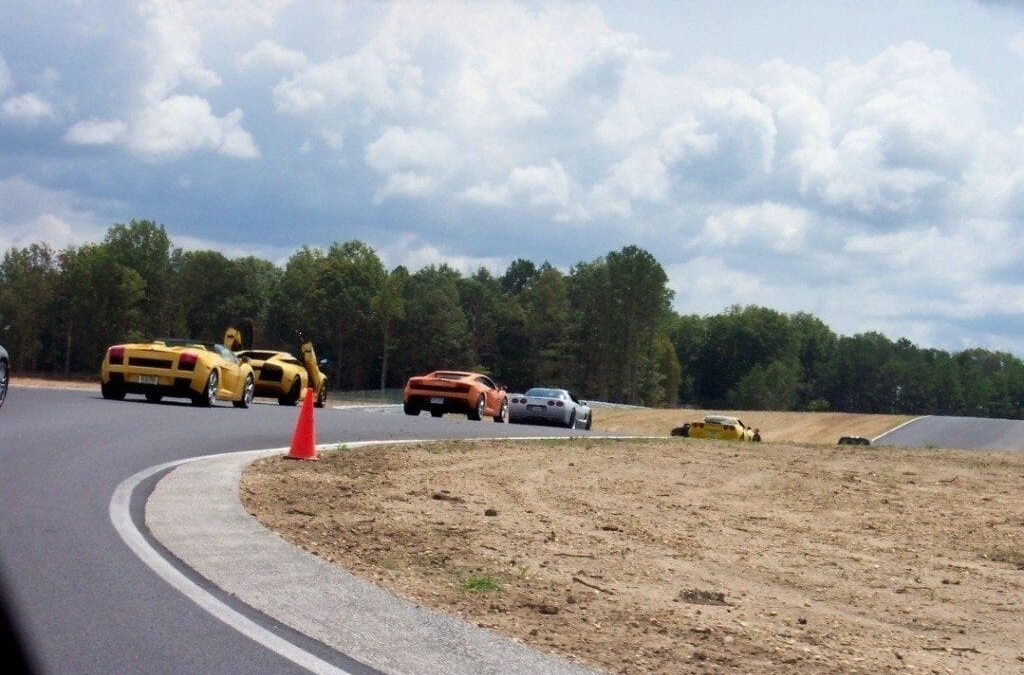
[240,438,1024,673]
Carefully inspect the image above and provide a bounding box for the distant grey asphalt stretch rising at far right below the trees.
[871,416,1024,451]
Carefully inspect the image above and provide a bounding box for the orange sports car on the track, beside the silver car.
[403,371,509,422]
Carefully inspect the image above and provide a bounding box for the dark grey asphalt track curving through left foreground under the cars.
[0,386,586,674]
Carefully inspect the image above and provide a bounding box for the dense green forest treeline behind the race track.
[0,220,1024,418]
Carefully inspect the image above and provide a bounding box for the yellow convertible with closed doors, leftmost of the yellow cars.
[100,338,256,408]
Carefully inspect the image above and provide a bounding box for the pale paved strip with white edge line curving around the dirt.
[111,436,593,675]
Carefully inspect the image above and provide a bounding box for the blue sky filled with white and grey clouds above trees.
[0,0,1024,355]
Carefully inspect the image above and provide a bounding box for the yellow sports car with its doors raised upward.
[224,328,327,408]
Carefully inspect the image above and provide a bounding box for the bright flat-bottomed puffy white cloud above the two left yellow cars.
[128,95,259,160]
